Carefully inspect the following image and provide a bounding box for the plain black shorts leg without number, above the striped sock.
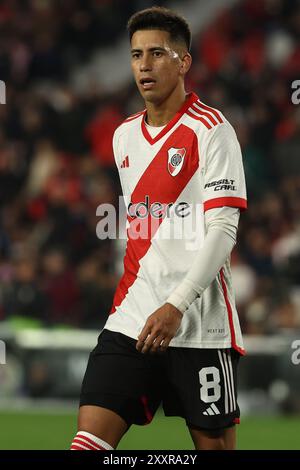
[80,330,160,427]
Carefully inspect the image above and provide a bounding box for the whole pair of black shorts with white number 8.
[80,330,240,429]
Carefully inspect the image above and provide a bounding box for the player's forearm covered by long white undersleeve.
[166,208,239,313]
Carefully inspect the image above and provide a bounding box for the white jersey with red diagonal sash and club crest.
[105,93,247,353]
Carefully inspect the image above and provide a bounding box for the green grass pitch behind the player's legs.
[0,410,300,450]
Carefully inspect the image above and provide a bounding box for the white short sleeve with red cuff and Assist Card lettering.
[203,122,247,211]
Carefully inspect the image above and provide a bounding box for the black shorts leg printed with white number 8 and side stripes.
[164,348,240,436]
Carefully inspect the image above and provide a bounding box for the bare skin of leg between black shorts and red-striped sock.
[78,405,128,448]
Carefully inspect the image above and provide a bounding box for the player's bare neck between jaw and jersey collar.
[146,88,187,127]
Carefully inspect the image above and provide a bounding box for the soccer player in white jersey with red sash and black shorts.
[71,7,247,450]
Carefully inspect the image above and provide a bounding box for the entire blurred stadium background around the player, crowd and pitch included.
[0,0,300,449]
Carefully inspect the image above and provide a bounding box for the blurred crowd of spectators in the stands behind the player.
[0,0,300,334]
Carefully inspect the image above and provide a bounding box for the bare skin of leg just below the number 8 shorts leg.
[189,426,236,450]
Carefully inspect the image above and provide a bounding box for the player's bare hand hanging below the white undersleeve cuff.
[136,303,183,353]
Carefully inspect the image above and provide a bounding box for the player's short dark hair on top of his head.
[127,6,192,51]
